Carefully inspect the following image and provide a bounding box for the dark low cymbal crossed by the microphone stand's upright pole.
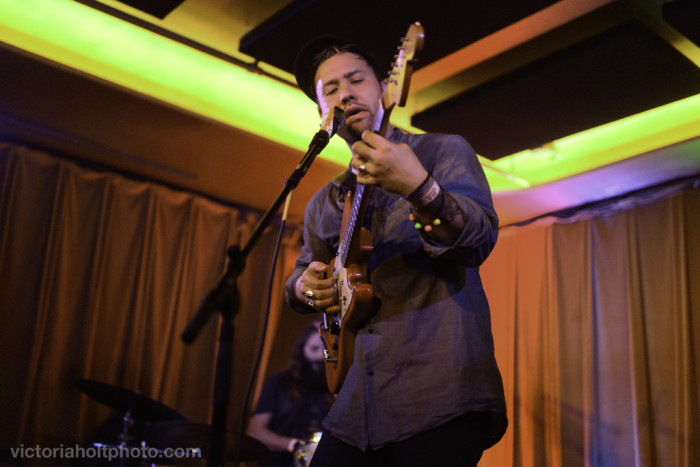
[144,421,268,462]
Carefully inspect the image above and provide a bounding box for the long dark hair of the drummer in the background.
[282,323,333,407]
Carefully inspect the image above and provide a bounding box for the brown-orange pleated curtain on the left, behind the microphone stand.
[0,143,300,464]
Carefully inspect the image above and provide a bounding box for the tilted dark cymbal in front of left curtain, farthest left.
[75,379,187,422]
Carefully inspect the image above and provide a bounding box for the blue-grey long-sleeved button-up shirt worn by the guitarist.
[286,131,506,449]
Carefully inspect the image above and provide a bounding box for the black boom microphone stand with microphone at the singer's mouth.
[182,107,344,467]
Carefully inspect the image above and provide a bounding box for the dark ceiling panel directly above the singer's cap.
[239,0,557,75]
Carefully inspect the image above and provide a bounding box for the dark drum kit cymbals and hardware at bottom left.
[75,379,268,467]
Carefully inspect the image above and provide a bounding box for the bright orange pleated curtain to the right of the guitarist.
[480,183,700,467]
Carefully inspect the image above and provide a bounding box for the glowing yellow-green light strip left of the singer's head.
[0,0,348,166]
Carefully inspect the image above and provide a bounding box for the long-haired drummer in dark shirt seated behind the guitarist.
[248,324,334,467]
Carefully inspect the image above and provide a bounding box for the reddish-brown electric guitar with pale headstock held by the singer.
[319,23,424,394]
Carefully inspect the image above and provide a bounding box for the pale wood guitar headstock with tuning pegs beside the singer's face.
[380,22,425,135]
